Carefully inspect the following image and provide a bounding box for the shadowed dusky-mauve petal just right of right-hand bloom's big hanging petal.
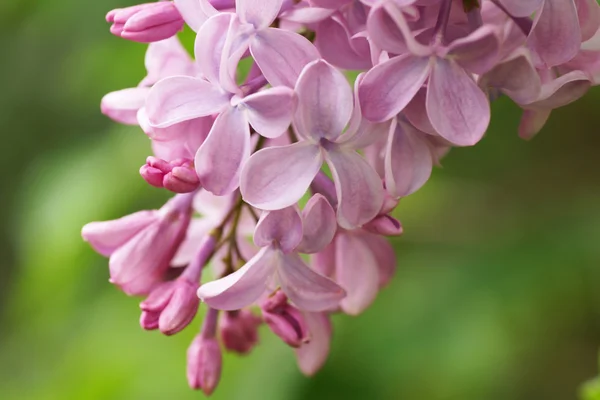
[479,50,542,104]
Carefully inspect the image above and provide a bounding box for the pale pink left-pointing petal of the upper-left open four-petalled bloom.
[146,76,229,128]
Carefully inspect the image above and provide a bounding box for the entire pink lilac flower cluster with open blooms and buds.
[83,0,600,394]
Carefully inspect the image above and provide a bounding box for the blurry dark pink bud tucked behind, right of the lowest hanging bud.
[219,310,262,354]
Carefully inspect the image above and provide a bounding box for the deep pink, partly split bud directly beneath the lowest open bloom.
[261,291,308,347]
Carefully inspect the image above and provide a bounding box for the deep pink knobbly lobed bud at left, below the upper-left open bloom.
[140,157,200,193]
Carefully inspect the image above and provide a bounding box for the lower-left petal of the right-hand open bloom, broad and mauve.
[359,56,431,122]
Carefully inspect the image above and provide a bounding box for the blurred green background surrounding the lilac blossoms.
[0,0,600,400]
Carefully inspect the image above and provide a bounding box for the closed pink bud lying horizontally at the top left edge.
[106,1,184,43]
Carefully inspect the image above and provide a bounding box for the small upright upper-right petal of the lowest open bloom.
[297,194,337,254]
